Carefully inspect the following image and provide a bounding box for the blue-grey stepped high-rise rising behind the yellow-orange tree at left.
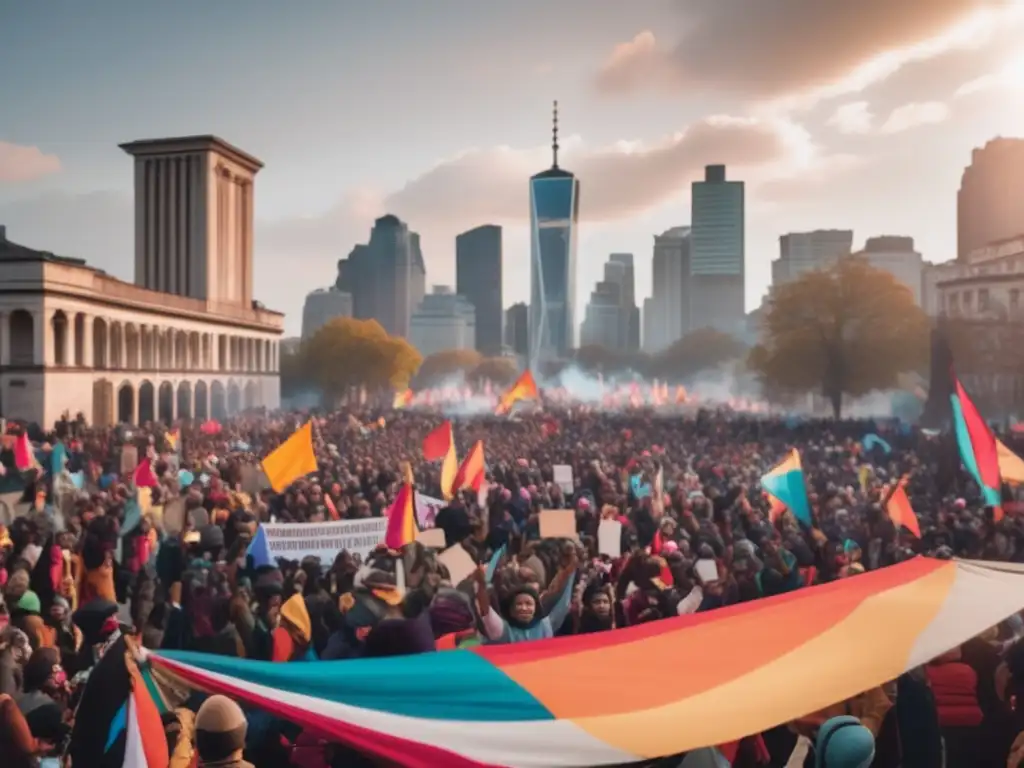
[335,214,427,338]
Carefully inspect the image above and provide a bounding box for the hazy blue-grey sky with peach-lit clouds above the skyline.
[0,0,1024,334]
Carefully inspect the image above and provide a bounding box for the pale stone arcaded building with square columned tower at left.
[0,136,284,427]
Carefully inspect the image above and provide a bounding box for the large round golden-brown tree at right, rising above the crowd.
[749,257,929,418]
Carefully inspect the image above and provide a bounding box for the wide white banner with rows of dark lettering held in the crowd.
[262,517,387,565]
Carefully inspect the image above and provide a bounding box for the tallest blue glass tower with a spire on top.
[529,101,580,366]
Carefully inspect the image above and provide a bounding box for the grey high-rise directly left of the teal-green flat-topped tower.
[643,226,692,352]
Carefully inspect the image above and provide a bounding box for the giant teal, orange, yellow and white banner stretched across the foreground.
[150,557,1024,768]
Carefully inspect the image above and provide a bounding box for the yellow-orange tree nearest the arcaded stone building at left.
[302,317,423,397]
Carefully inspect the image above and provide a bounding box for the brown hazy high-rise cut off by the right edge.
[956,137,1024,261]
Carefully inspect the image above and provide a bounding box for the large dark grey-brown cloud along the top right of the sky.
[596,0,1024,105]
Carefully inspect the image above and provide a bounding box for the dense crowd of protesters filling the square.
[0,406,1024,768]
